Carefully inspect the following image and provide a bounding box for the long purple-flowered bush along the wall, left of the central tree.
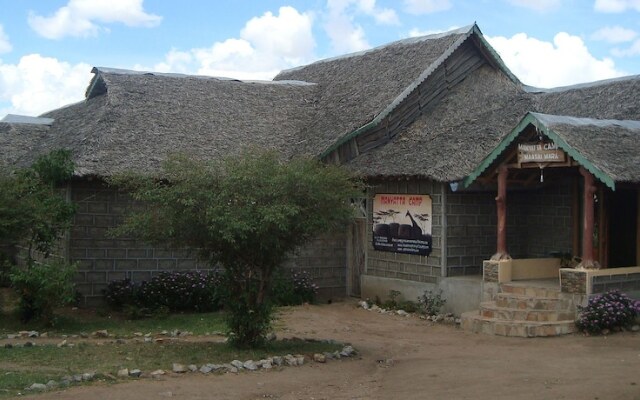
[104,271,221,318]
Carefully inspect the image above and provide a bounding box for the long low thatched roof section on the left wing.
[5,68,315,176]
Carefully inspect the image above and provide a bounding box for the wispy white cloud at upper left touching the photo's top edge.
[28,0,162,39]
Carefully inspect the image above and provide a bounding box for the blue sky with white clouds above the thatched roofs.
[0,0,640,118]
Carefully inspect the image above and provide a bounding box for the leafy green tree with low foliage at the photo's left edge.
[0,150,75,323]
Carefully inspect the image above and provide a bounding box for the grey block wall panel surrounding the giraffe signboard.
[365,180,442,283]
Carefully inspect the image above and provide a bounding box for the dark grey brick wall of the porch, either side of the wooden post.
[442,180,573,276]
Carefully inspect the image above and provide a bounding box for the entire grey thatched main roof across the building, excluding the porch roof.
[0,25,640,181]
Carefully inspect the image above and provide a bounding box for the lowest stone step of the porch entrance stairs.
[461,311,576,338]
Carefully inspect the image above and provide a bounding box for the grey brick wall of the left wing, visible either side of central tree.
[67,181,346,306]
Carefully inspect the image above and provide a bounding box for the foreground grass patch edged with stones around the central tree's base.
[0,340,342,398]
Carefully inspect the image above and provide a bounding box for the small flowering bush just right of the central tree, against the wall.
[271,270,318,306]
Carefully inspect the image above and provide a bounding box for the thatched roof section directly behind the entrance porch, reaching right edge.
[342,72,640,182]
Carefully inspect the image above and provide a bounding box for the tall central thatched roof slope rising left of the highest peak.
[274,26,473,156]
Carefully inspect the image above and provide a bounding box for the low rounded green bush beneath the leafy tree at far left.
[10,261,77,325]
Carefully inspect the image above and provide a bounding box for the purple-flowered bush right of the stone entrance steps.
[576,290,640,333]
